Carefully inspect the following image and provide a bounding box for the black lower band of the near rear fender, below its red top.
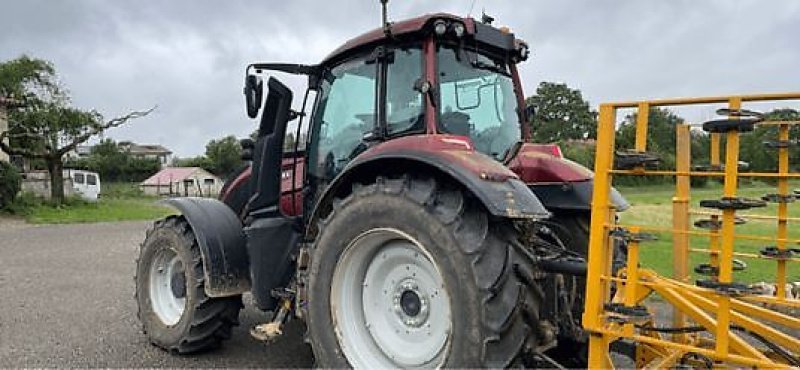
[309,151,551,236]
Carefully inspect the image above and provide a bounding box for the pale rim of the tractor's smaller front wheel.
[150,248,186,326]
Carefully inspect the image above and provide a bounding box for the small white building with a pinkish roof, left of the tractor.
[139,167,223,197]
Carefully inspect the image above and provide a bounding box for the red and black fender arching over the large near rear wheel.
[310,135,550,236]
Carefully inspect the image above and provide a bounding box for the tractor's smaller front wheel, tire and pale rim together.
[134,216,242,354]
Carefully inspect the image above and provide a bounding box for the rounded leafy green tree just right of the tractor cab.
[525,82,597,143]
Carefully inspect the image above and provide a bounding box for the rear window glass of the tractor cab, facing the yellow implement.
[437,45,521,160]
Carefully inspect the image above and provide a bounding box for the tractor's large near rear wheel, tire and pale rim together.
[308,178,541,368]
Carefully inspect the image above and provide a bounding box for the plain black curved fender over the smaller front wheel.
[162,197,251,297]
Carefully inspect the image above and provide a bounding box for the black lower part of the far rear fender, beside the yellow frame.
[528,179,630,212]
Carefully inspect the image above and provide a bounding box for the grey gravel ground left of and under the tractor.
[0,219,313,368]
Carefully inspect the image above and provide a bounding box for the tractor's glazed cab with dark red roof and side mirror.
[245,13,528,209]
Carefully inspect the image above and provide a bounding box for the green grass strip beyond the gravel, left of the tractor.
[22,183,175,224]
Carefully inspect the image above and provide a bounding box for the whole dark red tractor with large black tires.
[136,7,626,368]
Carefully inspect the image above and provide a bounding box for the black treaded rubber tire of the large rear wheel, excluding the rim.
[308,177,541,368]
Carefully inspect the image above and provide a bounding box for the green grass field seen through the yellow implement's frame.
[619,183,800,282]
